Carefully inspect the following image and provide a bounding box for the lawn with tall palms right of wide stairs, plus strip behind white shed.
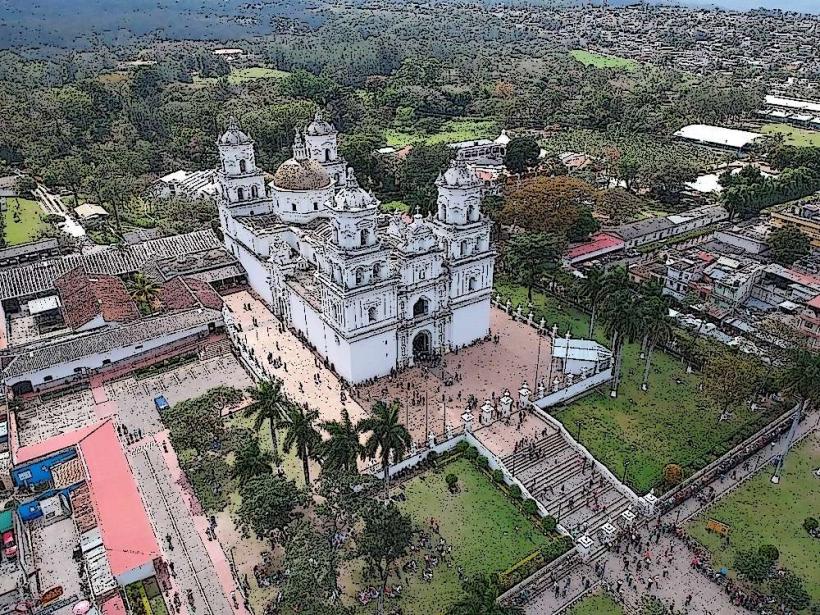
[496,283,780,493]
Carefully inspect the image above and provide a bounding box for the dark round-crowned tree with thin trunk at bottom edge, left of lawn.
[356,502,413,613]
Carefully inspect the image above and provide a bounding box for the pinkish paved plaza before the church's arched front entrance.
[355,308,550,454]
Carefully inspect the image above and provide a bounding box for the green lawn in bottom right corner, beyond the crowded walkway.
[688,432,820,601]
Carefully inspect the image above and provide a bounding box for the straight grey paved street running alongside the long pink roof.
[128,439,233,615]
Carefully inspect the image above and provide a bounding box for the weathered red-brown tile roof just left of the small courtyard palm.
[54,267,140,329]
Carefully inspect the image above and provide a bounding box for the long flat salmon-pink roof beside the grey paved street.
[79,420,160,578]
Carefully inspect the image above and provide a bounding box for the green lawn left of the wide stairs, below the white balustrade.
[342,459,550,615]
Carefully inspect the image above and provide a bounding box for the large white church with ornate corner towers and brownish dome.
[217,112,495,383]
